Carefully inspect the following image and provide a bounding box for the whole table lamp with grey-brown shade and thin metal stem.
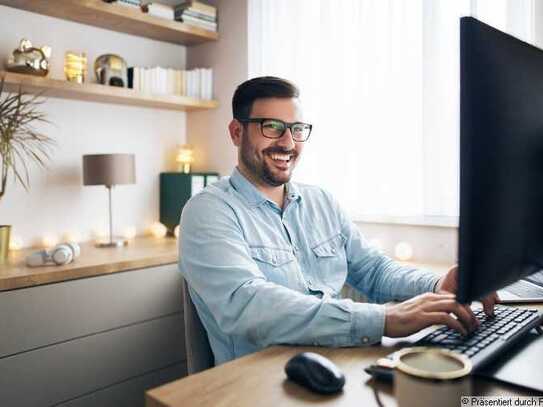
[83,154,136,247]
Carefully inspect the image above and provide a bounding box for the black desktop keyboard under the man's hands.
[416,305,542,371]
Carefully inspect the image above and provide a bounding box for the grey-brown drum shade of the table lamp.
[83,154,136,186]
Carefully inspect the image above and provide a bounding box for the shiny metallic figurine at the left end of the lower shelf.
[6,38,51,76]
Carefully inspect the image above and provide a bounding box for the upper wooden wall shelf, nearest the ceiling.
[0,0,219,45]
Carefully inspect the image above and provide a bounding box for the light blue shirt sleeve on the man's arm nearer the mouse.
[180,193,385,347]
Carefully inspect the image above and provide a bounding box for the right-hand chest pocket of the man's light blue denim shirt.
[311,233,347,294]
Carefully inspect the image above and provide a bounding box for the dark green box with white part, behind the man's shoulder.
[160,172,219,233]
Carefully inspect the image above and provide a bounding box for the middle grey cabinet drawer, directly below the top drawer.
[0,313,185,407]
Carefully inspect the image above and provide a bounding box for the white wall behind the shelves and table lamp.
[0,6,186,246]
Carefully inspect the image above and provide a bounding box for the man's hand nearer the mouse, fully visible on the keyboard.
[385,292,479,337]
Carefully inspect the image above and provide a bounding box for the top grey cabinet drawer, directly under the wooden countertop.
[0,264,183,358]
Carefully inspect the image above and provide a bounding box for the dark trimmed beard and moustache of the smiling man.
[241,132,298,187]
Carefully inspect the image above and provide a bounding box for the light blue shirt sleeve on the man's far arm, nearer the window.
[335,199,439,303]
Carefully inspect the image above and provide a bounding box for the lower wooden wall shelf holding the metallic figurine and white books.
[0,71,218,111]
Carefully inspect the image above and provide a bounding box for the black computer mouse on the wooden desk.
[285,352,345,394]
